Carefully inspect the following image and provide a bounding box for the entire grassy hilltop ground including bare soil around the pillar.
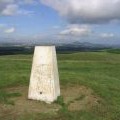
[0,51,120,120]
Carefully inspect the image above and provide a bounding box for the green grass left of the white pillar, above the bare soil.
[0,55,32,88]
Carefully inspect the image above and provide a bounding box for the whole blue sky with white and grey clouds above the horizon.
[0,0,120,44]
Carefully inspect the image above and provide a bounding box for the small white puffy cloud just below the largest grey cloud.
[60,25,92,37]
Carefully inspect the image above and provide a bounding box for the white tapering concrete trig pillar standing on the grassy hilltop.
[28,46,60,103]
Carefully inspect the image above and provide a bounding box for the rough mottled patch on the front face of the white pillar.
[33,64,53,94]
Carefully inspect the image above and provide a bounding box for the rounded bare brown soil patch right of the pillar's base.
[61,85,100,111]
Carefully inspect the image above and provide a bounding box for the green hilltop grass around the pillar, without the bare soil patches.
[0,51,120,120]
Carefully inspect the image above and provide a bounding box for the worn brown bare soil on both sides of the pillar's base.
[0,85,99,120]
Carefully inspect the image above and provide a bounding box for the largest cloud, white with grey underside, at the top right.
[40,0,120,23]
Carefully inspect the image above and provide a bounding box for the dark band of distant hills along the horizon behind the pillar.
[0,41,120,55]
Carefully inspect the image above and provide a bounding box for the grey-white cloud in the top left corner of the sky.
[0,0,34,16]
